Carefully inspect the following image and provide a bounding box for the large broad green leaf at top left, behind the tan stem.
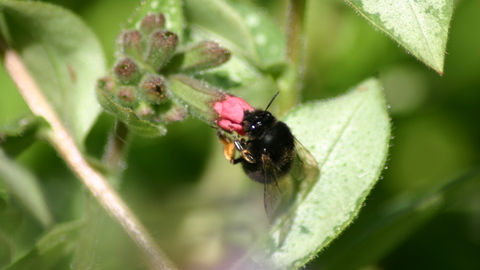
[0,1,106,146]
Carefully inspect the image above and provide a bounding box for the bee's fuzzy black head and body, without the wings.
[239,110,295,184]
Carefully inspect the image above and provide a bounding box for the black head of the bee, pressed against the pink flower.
[242,109,277,139]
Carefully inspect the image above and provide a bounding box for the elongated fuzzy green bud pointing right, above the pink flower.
[180,40,231,72]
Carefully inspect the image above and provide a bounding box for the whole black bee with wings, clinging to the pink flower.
[218,93,318,220]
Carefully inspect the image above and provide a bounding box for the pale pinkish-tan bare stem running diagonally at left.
[0,42,177,270]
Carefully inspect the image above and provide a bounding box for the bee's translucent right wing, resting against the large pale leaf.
[290,139,320,200]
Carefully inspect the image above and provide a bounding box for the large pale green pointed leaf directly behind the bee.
[236,79,390,269]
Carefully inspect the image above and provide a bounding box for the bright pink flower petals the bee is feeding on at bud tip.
[213,95,254,136]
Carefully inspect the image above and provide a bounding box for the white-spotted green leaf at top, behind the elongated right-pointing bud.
[185,0,285,68]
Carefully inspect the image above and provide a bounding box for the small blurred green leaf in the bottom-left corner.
[5,221,82,270]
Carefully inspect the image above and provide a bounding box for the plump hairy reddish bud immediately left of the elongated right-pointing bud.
[145,31,178,71]
